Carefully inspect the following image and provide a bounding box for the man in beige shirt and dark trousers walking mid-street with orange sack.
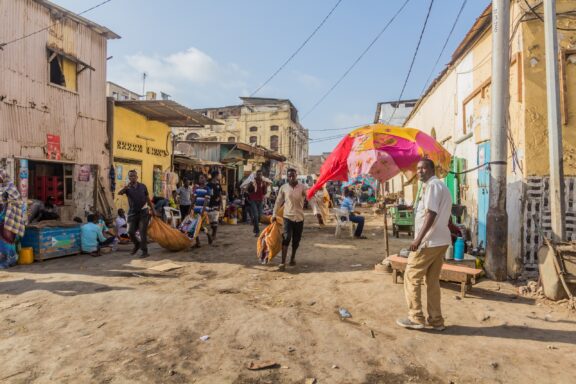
[272,168,307,271]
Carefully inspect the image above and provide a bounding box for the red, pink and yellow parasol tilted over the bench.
[308,124,451,199]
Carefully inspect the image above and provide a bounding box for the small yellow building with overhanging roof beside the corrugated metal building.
[108,98,215,209]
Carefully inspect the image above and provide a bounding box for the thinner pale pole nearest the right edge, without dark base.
[544,0,566,241]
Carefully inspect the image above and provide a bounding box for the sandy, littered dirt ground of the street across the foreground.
[0,212,576,383]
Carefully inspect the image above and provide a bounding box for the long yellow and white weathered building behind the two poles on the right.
[396,0,576,276]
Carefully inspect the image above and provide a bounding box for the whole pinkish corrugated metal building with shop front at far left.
[0,0,119,218]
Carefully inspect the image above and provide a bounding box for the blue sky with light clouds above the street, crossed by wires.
[52,0,490,154]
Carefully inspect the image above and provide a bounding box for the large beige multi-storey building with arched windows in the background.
[174,97,308,175]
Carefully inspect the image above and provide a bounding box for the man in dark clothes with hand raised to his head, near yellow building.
[118,170,154,258]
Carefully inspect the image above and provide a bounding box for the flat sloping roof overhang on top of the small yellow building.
[114,100,222,127]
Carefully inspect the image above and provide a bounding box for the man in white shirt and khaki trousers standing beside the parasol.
[396,159,452,331]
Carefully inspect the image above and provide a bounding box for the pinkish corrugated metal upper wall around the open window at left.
[0,0,109,171]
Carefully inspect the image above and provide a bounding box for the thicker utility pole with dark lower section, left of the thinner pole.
[486,0,510,281]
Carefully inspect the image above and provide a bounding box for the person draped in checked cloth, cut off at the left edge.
[0,169,26,269]
